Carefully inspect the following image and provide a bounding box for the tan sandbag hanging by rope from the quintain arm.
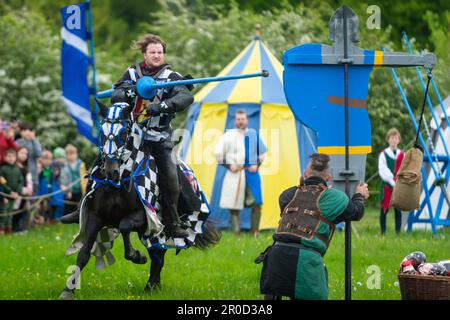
[391,148,423,211]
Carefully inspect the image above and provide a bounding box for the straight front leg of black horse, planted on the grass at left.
[59,214,103,300]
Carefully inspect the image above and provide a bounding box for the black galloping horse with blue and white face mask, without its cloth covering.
[59,103,221,299]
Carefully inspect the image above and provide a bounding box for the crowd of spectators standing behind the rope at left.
[0,119,86,236]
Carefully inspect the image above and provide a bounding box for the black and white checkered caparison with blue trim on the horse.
[66,117,210,268]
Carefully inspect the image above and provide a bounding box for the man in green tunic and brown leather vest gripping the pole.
[255,153,369,300]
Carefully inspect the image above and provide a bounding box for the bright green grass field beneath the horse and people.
[0,210,450,300]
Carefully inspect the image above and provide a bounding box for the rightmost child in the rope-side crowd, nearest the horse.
[61,144,86,213]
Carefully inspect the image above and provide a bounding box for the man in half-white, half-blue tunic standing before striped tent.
[215,110,267,236]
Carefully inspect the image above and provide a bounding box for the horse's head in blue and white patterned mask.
[99,99,132,181]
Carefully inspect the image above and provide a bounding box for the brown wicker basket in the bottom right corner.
[398,273,450,300]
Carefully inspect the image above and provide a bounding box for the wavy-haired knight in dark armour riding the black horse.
[61,34,194,238]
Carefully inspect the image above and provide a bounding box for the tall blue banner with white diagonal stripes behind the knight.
[60,3,96,143]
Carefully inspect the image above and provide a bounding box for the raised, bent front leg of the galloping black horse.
[119,210,147,264]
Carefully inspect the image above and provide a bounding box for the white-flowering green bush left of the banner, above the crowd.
[0,9,95,159]
